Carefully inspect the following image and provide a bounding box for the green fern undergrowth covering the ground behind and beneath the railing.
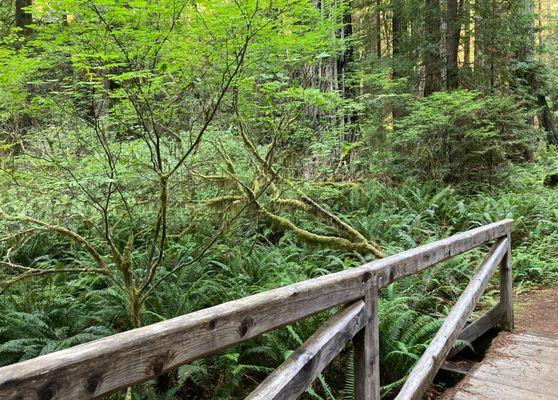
[0,154,558,399]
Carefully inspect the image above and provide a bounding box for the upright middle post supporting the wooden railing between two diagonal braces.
[353,275,380,400]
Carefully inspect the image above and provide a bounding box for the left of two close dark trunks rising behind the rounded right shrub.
[424,0,442,96]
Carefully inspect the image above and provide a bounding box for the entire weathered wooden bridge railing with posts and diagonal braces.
[0,220,513,400]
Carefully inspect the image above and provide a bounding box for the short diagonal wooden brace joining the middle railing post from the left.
[246,300,369,400]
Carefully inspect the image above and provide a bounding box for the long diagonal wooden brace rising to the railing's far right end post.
[396,238,508,400]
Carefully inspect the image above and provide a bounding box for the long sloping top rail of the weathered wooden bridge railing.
[0,220,513,400]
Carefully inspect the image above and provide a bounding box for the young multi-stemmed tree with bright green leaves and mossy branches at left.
[2,0,288,327]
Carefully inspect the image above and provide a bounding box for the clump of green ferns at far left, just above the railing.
[0,277,116,365]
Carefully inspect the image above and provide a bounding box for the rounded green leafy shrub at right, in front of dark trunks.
[392,90,536,184]
